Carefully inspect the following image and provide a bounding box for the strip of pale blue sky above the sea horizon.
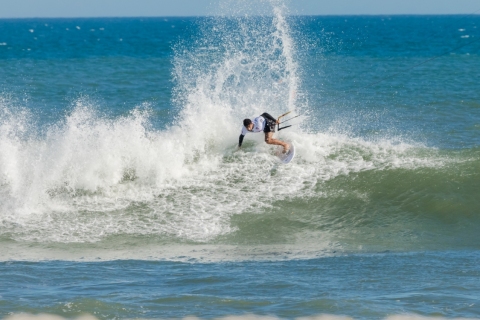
[0,0,480,18]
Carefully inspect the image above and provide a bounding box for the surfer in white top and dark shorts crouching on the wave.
[238,112,289,153]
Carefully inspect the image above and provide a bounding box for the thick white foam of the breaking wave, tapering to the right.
[0,97,443,248]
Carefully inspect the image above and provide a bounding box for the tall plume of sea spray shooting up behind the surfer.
[174,1,300,149]
